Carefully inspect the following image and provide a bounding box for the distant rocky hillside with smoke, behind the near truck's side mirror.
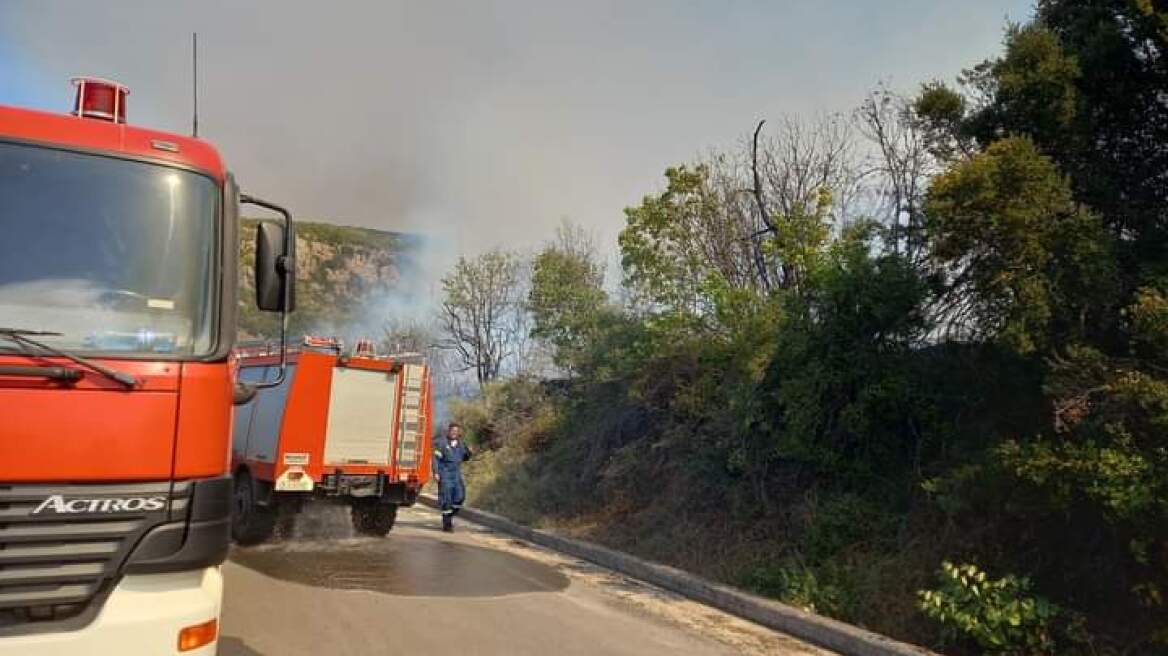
[238,218,422,339]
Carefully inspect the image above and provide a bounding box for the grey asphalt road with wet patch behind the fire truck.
[220,507,827,656]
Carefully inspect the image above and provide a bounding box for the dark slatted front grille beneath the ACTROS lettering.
[0,482,182,630]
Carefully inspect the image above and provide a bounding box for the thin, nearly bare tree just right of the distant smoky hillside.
[438,250,523,388]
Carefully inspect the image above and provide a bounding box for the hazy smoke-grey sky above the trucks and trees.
[0,0,1031,257]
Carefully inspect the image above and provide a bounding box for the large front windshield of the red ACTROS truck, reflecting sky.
[0,144,218,357]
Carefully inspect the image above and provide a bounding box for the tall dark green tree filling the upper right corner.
[939,5,1168,288]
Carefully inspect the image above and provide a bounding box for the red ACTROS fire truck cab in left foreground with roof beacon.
[0,78,294,656]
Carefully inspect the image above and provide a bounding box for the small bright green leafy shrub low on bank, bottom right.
[918,563,1062,655]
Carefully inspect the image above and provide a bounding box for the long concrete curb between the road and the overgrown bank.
[418,494,933,656]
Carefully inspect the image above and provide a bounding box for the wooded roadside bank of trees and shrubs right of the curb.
[441,0,1168,654]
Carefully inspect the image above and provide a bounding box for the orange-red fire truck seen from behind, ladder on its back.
[231,336,432,544]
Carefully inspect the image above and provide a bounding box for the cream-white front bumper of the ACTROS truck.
[0,566,223,656]
